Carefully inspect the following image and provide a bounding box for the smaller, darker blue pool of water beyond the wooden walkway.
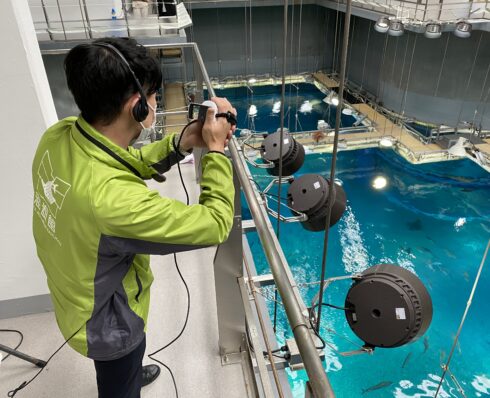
[216,83,357,133]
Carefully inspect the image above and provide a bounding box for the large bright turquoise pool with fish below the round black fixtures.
[244,149,490,398]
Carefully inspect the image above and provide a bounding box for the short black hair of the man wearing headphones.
[64,38,162,125]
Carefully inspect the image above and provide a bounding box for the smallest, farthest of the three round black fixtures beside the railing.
[260,133,305,176]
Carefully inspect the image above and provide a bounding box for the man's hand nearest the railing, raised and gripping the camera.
[202,97,236,152]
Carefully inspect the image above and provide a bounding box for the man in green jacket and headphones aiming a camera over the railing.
[32,39,236,398]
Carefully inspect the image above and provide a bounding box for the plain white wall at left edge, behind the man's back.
[0,0,57,305]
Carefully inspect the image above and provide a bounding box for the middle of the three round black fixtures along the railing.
[288,174,347,232]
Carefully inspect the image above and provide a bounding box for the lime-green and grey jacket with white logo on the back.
[32,117,234,360]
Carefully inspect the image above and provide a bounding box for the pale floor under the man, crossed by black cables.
[0,164,246,398]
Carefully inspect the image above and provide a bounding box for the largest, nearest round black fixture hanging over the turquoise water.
[345,264,432,348]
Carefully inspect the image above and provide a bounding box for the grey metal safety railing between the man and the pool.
[40,38,335,398]
